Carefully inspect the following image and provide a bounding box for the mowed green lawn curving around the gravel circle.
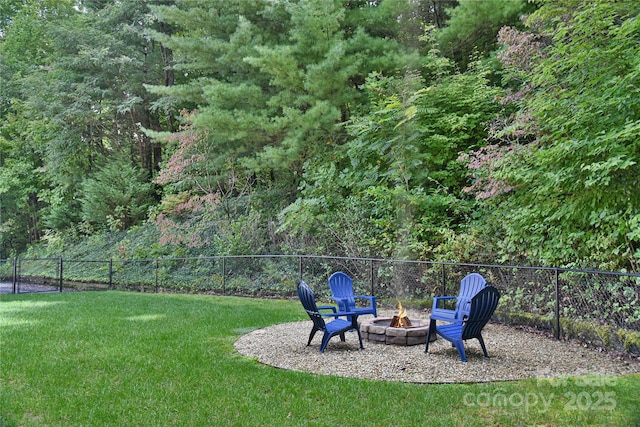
[0,291,640,426]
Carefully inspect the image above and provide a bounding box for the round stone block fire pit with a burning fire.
[360,317,435,346]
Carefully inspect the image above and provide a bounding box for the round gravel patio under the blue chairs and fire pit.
[235,310,640,383]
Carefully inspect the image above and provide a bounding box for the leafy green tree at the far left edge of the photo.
[0,0,73,257]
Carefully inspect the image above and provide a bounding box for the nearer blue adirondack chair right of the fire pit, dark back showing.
[424,285,500,362]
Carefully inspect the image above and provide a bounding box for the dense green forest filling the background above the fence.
[0,0,640,271]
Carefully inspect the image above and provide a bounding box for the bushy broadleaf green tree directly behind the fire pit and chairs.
[285,46,501,257]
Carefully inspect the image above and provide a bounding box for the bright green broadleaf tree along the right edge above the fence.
[464,0,640,270]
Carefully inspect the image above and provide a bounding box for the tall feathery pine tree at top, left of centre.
[152,0,430,251]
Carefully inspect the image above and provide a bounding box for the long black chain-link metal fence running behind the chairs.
[0,255,640,351]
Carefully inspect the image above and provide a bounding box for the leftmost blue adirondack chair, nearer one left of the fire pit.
[298,280,364,353]
